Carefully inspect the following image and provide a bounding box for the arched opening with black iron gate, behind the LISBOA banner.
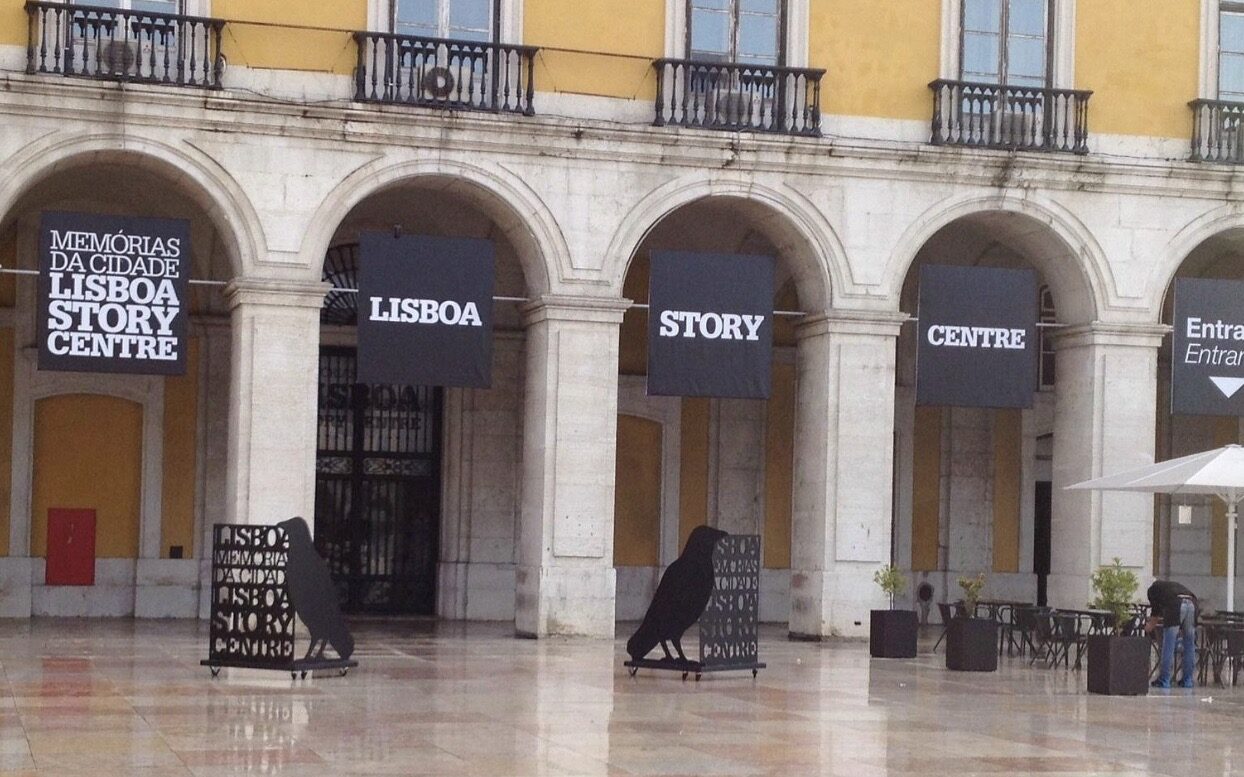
[315,175,531,620]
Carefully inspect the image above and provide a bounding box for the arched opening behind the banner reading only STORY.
[613,195,829,623]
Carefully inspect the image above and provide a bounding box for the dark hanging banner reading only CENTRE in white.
[916,265,1040,408]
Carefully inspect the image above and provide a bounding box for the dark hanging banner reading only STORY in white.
[648,251,774,399]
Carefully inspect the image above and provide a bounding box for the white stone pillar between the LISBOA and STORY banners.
[515,296,629,638]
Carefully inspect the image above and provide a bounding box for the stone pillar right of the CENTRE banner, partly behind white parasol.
[1047,323,1164,608]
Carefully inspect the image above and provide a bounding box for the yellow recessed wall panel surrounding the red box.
[30,394,143,558]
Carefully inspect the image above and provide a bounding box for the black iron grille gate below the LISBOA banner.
[315,347,442,614]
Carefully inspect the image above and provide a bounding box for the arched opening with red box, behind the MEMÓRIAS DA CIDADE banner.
[0,150,243,617]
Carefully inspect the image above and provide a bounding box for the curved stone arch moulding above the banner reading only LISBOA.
[302,159,570,296]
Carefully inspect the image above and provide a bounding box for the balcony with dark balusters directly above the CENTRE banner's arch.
[929,80,1092,154]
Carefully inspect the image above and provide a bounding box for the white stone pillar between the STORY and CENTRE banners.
[790,311,903,639]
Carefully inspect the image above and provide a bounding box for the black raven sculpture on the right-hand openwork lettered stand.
[626,526,726,663]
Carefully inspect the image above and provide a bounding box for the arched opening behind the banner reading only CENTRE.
[893,210,1093,618]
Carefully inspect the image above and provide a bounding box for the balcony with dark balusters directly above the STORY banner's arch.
[653,60,825,137]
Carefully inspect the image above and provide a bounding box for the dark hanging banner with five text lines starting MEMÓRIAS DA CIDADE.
[37,213,190,375]
